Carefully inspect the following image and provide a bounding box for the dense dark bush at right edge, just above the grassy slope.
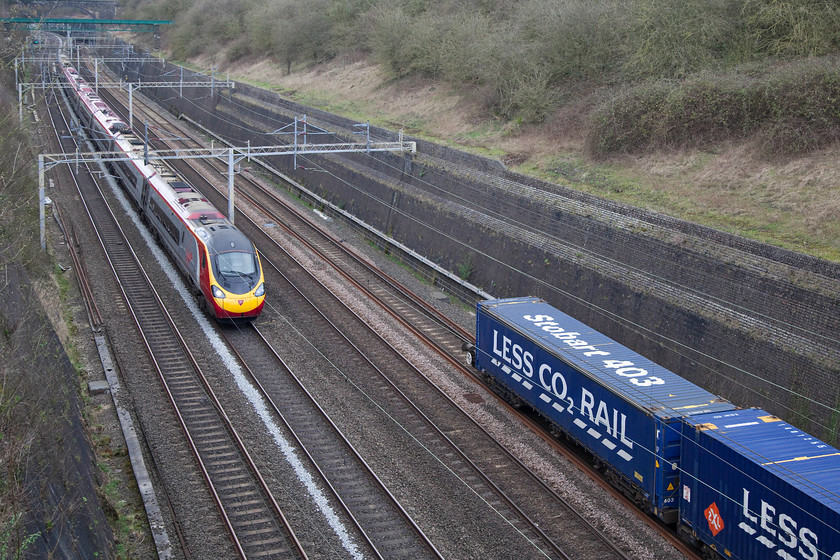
[587,58,840,157]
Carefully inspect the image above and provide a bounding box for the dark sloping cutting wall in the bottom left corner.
[0,262,114,559]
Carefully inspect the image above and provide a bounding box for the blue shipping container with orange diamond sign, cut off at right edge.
[680,409,840,560]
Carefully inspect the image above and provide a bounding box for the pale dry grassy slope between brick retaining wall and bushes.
[193,53,840,262]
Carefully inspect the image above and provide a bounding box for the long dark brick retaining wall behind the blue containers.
[105,46,840,444]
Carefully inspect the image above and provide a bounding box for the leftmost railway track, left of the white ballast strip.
[51,64,307,559]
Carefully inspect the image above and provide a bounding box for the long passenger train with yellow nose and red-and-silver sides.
[61,57,265,321]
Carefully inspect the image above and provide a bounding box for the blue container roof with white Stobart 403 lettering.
[478,298,735,418]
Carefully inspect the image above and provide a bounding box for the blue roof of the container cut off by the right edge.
[686,408,840,512]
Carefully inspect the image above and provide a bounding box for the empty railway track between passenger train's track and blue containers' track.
[241,214,625,558]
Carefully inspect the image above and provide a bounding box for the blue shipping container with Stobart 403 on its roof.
[475,298,735,523]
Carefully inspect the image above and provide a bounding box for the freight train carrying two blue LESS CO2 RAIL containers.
[470,298,840,560]
